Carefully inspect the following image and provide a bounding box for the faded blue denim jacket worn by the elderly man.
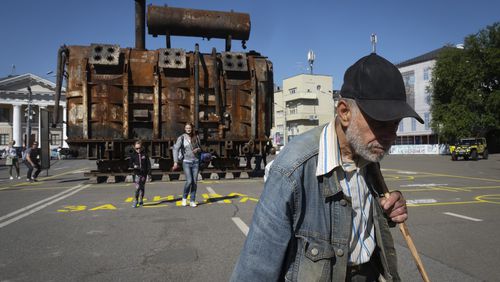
[231,126,400,281]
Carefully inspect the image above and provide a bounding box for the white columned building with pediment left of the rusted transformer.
[0,73,68,149]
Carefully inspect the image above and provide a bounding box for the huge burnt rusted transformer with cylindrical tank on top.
[54,0,273,172]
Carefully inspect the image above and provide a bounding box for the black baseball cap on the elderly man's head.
[340,53,424,124]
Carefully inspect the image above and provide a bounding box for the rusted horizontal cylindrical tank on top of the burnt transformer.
[147,5,250,40]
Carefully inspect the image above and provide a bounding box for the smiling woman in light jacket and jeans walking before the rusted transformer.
[172,123,201,207]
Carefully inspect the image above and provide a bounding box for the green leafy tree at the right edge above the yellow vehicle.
[431,22,500,141]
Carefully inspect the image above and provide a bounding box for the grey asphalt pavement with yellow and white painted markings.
[0,154,500,281]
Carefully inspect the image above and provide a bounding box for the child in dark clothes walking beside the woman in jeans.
[129,141,151,208]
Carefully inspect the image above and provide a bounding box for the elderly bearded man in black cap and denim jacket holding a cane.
[231,53,423,281]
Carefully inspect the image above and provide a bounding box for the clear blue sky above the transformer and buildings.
[0,0,500,89]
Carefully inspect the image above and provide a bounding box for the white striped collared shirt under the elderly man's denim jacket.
[316,121,376,265]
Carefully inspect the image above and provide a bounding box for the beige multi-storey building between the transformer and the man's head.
[271,74,334,148]
